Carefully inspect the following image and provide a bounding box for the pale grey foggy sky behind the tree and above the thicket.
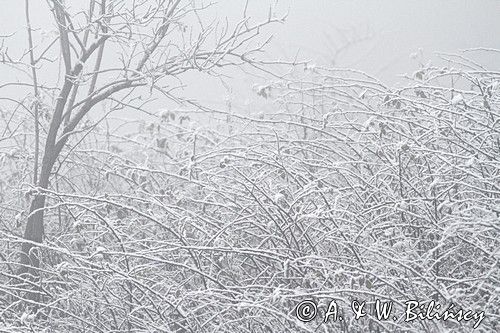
[0,0,500,110]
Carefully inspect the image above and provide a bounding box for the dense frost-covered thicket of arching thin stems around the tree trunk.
[0,1,500,332]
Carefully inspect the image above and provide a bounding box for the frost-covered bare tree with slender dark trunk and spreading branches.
[3,0,282,296]
